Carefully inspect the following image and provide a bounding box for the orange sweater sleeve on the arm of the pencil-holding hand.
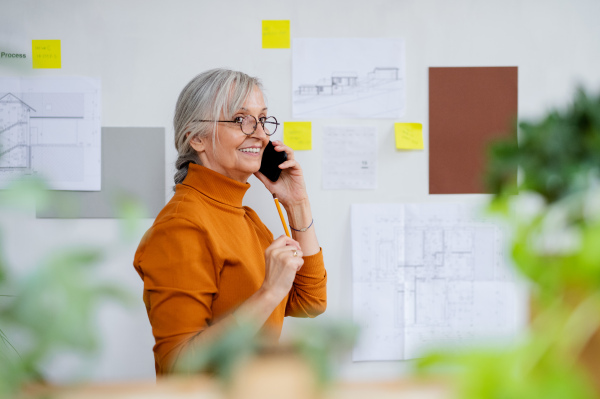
[135,218,219,374]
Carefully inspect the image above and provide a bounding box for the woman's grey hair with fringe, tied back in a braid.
[173,69,262,188]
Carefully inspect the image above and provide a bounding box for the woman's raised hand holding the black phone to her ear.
[254,140,308,209]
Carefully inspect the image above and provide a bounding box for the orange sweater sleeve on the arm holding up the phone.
[285,250,327,317]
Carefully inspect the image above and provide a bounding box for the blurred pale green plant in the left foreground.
[0,179,134,398]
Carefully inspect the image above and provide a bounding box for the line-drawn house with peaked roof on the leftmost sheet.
[0,93,35,170]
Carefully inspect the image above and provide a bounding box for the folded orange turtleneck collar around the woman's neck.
[182,163,250,208]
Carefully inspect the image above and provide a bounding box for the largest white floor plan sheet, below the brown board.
[351,203,525,361]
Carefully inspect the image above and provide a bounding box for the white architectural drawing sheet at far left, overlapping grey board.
[0,77,101,191]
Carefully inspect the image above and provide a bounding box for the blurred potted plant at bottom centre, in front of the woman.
[171,320,358,399]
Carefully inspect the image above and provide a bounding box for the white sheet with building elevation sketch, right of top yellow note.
[292,39,405,119]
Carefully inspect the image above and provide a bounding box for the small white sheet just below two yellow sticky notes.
[322,125,377,190]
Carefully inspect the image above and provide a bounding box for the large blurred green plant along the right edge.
[417,90,600,399]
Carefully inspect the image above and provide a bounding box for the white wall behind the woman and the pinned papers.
[0,0,600,380]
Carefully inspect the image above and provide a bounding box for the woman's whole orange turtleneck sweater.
[133,164,327,374]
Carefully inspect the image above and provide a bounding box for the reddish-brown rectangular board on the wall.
[429,67,518,194]
